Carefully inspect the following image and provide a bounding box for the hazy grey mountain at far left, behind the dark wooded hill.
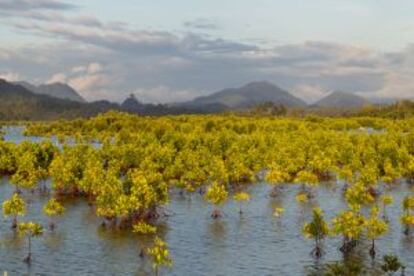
[15,81,86,103]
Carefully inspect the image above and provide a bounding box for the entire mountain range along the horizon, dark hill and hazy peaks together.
[0,79,402,120]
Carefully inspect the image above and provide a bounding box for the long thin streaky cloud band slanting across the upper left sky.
[9,22,257,56]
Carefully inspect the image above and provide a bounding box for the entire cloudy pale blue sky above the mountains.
[0,0,414,102]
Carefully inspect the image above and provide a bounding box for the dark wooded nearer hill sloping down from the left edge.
[0,79,220,121]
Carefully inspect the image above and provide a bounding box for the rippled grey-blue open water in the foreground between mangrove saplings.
[0,128,414,276]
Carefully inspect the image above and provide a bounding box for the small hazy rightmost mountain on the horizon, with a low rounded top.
[313,91,369,108]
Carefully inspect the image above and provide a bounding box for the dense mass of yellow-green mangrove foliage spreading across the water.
[0,112,414,258]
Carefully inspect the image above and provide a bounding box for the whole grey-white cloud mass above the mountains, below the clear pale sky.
[0,5,414,102]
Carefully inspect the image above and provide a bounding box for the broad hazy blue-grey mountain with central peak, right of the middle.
[184,81,306,109]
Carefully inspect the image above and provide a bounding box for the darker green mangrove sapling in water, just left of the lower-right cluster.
[303,208,329,258]
